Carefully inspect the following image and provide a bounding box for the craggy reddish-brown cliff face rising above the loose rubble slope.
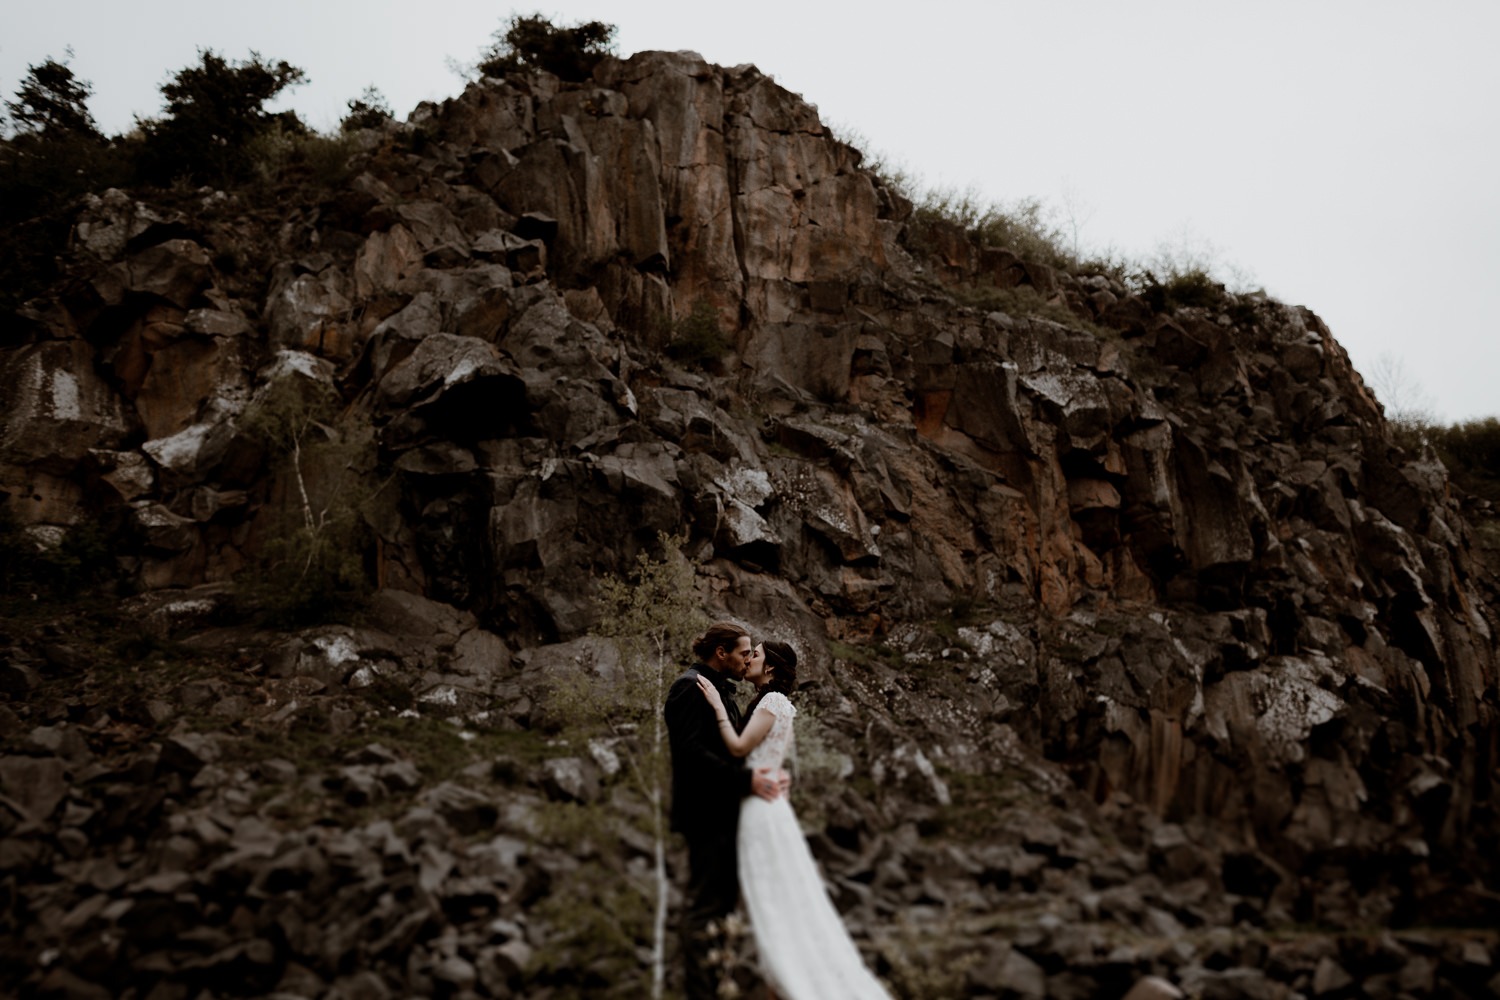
[0,52,1497,975]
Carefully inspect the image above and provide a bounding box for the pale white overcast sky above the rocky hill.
[0,0,1500,420]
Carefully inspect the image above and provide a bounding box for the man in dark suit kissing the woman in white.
[665,622,783,1000]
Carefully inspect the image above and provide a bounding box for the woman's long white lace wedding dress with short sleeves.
[740,691,890,1000]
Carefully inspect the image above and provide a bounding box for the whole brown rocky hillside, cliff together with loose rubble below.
[0,52,1500,997]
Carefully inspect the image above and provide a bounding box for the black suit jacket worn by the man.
[665,664,752,837]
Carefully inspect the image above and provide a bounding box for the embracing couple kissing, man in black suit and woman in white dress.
[665,622,888,1000]
